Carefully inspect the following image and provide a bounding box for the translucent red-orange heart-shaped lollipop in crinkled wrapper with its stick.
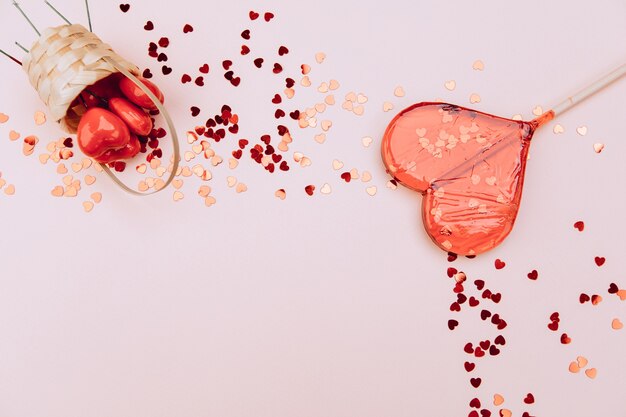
[382,65,626,255]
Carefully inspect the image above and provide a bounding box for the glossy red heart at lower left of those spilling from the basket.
[77,107,130,160]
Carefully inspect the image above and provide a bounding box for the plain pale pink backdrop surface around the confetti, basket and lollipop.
[0,0,626,417]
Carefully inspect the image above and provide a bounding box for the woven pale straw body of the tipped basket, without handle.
[23,25,139,133]
